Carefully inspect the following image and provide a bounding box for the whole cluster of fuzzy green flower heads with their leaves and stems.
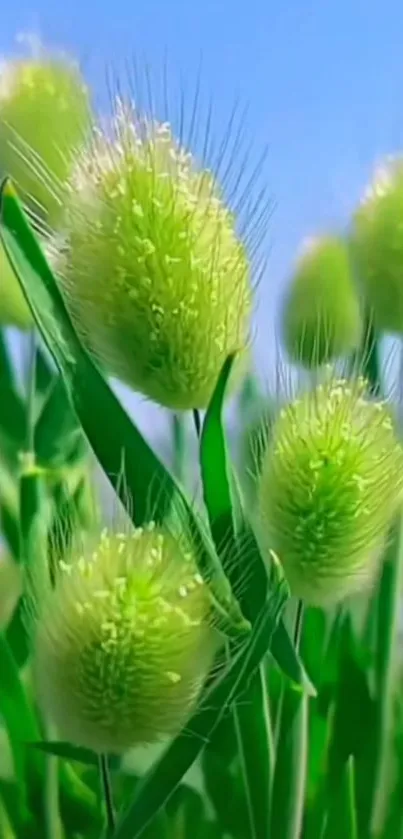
[0,42,403,839]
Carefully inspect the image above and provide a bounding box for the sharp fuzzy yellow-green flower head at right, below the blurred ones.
[258,379,403,606]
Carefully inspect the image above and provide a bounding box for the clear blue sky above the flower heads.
[0,0,403,440]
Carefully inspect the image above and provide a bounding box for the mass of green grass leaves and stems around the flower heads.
[0,59,403,839]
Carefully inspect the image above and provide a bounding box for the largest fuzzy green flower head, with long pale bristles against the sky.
[61,103,251,410]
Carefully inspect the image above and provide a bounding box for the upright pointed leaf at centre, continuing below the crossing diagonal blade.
[200,355,282,839]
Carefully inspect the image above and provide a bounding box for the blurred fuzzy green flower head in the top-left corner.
[0,56,89,222]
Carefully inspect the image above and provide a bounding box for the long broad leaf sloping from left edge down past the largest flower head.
[0,180,250,636]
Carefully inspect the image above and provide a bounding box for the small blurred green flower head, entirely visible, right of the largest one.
[283,236,362,368]
